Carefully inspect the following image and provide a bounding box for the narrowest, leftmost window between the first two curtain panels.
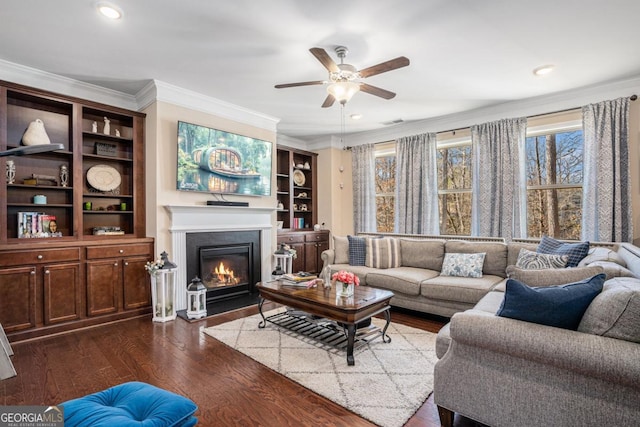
[375,143,396,233]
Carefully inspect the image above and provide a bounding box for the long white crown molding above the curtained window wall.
[328,76,640,149]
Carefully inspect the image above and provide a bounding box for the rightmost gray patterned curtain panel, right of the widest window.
[582,98,633,242]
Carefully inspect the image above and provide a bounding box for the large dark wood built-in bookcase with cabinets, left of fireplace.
[0,81,154,341]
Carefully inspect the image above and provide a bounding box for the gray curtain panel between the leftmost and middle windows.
[395,133,440,234]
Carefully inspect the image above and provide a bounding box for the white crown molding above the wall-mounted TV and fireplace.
[136,80,280,132]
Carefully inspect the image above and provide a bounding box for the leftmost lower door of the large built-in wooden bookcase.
[0,267,36,332]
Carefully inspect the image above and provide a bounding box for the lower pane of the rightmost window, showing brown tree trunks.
[527,187,582,240]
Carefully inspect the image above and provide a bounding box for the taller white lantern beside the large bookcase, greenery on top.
[151,252,178,322]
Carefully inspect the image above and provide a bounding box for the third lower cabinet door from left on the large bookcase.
[87,259,122,316]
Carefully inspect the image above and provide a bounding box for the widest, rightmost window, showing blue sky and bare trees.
[526,121,584,240]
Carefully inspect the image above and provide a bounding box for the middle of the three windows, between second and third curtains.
[437,137,471,235]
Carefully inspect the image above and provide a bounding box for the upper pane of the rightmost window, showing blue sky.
[526,130,584,185]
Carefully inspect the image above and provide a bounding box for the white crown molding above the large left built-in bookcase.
[0,59,138,111]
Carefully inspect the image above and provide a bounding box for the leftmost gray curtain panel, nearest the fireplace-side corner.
[351,144,377,233]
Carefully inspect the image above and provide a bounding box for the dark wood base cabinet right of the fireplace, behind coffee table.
[278,230,329,273]
